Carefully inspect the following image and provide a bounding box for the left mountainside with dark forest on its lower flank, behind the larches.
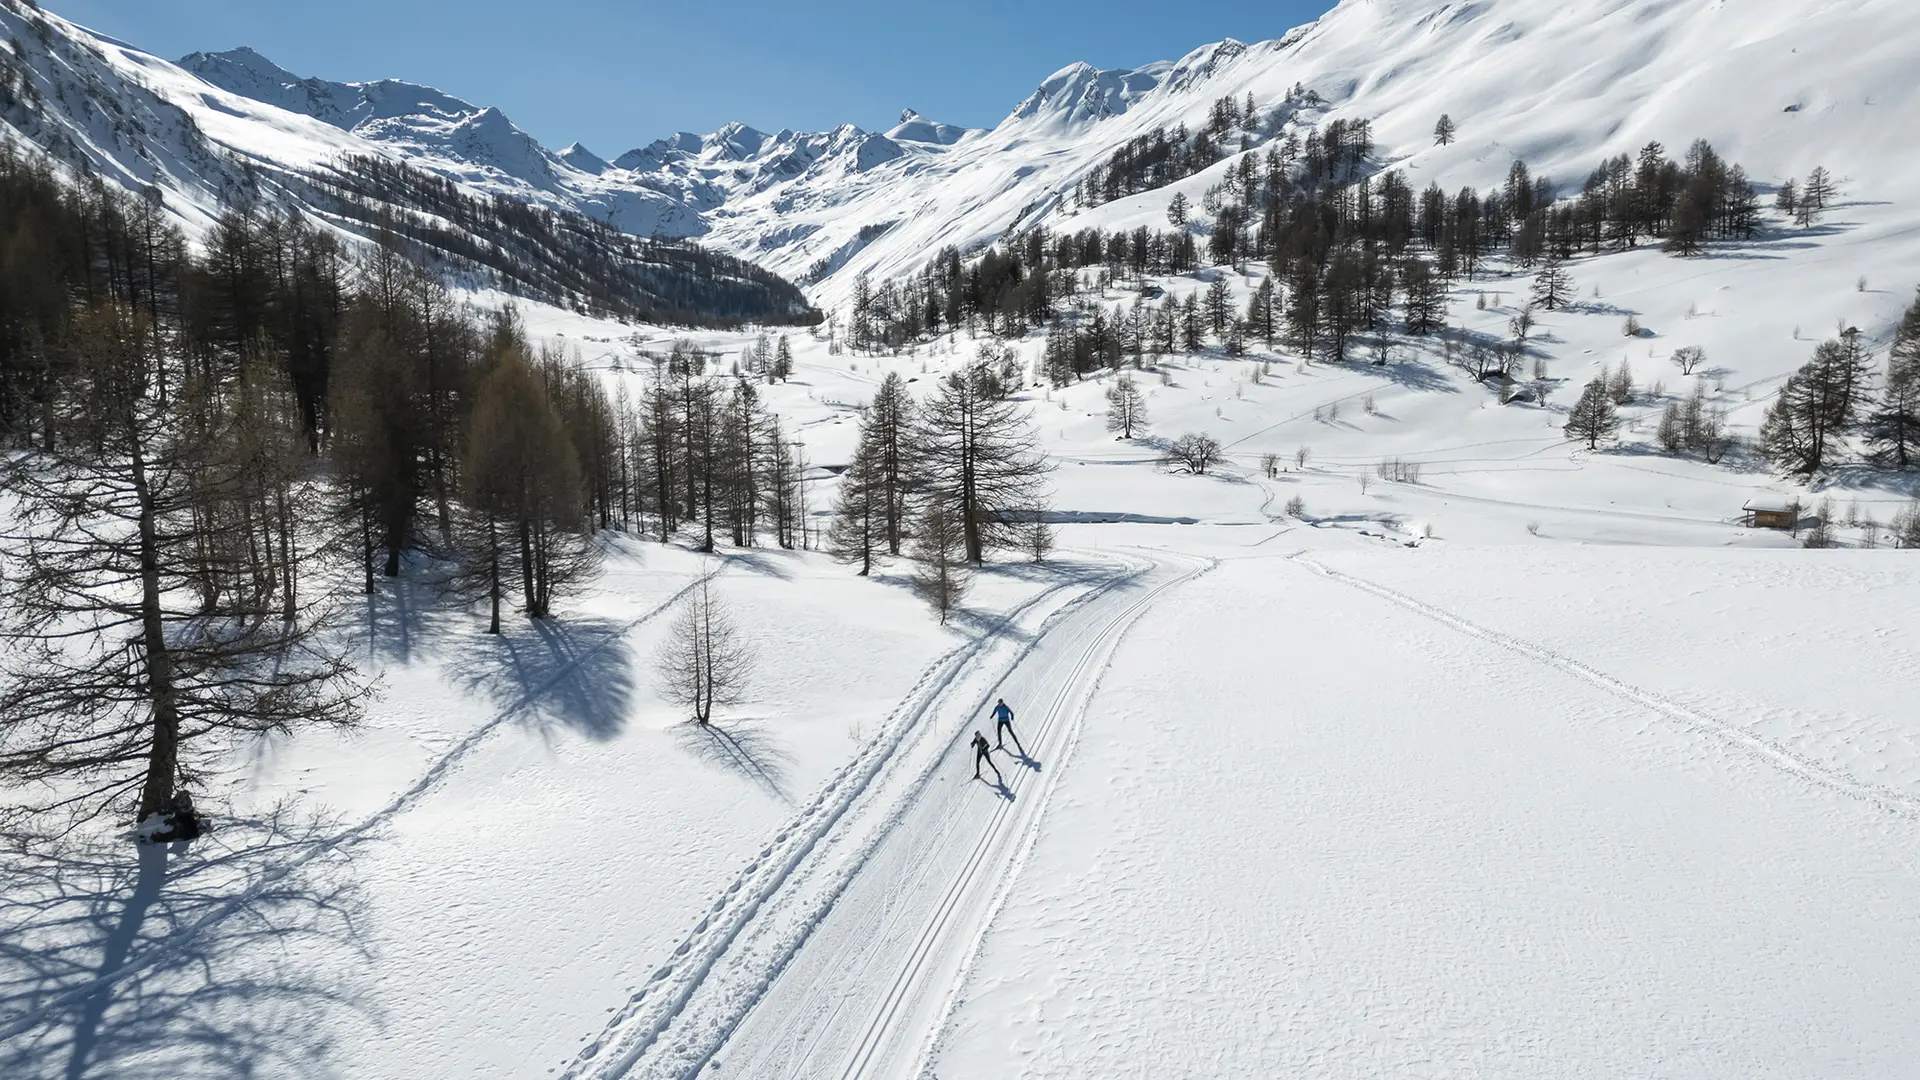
[0,0,812,321]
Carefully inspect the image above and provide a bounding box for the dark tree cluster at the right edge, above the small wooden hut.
[1761,298,1920,479]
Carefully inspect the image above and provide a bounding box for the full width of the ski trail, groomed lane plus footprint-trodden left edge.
[563,553,1206,1080]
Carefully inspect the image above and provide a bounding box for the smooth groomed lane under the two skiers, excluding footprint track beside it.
[622,553,1212,1080]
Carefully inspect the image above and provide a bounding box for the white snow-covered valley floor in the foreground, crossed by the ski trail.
[0,305,1920,1078]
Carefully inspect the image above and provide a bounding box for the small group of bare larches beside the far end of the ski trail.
[828,363,1052,621]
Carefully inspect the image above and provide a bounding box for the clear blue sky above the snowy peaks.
[42,0,1332,156]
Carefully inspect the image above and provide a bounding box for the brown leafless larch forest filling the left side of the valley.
[0,148,833,817]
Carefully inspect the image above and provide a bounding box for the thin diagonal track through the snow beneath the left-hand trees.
[0,567,724,1042]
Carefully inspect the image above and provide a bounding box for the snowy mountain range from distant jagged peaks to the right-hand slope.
[22,0,1920,317]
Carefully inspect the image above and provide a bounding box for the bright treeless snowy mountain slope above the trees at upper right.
[775,0,1920,304]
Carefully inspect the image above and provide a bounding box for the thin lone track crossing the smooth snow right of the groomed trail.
[1292,555,1920,819]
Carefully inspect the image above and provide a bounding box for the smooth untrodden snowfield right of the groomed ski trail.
[925,534,1920,1078]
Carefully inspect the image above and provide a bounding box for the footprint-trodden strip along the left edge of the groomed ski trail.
[561,563,1152,1080]
